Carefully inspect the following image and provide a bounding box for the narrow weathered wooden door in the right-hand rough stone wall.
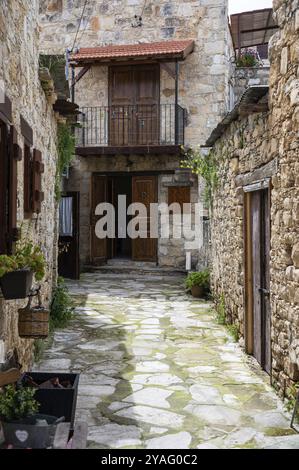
[244,186,271,374]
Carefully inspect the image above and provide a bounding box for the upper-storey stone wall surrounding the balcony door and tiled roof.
[40,0,232,145]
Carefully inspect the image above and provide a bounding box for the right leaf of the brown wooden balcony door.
[134,65,160,145]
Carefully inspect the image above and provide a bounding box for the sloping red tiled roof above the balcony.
[71,39,194,63]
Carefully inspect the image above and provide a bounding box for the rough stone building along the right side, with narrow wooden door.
[207,0,299,396]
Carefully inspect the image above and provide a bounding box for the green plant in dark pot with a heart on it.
[0,385,61,449]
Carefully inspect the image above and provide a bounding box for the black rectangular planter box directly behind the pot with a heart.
[26,372,80,430]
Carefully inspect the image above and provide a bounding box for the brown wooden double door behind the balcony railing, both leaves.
[109,64,160,146]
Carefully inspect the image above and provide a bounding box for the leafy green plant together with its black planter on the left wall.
[0,242,45,300]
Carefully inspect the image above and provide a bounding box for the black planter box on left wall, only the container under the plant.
[0,269,33,300]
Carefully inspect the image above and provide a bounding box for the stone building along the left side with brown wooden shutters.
[0,0,61,368]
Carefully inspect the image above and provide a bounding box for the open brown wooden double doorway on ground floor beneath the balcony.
[90,173,157,265]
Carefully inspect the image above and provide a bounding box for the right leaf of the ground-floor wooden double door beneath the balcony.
[132,176,157,261]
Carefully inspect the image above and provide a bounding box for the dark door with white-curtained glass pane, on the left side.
[58,192,80,279]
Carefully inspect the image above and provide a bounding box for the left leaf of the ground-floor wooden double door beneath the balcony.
[90,174,108,265]
